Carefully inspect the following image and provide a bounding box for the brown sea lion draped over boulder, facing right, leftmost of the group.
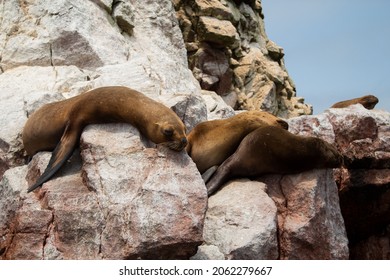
[22,86,187,192]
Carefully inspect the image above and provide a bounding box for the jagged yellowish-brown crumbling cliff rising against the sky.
[174,0,312,118]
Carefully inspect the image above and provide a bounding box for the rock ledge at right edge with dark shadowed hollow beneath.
[289,104,390,258]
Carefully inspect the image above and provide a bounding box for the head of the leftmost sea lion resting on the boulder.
[152,121,188,151]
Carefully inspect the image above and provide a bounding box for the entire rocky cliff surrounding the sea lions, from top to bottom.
[0,0,390,259]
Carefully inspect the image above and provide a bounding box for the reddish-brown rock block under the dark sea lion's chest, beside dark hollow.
[258,167,349,260]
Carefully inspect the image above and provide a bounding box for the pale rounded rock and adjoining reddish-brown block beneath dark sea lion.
[194,169,349,260]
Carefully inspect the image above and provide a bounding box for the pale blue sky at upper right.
[261,0,390,114]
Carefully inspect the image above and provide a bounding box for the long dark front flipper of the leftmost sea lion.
[27,121,79,192]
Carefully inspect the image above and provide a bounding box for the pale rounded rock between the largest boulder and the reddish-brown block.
[204,180,278,259]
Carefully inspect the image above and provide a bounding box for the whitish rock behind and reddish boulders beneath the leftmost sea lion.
[0,0,207,259]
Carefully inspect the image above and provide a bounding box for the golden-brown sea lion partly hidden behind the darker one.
[186,111,288,174]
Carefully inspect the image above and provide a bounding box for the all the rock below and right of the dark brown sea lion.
[194,105,390,259]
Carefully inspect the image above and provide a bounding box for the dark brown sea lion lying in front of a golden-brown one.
[206,126,342,196]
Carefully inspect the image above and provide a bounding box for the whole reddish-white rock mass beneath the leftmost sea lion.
[0,124,207,259]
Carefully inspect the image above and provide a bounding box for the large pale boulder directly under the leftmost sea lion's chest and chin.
[81,125,207,259]
